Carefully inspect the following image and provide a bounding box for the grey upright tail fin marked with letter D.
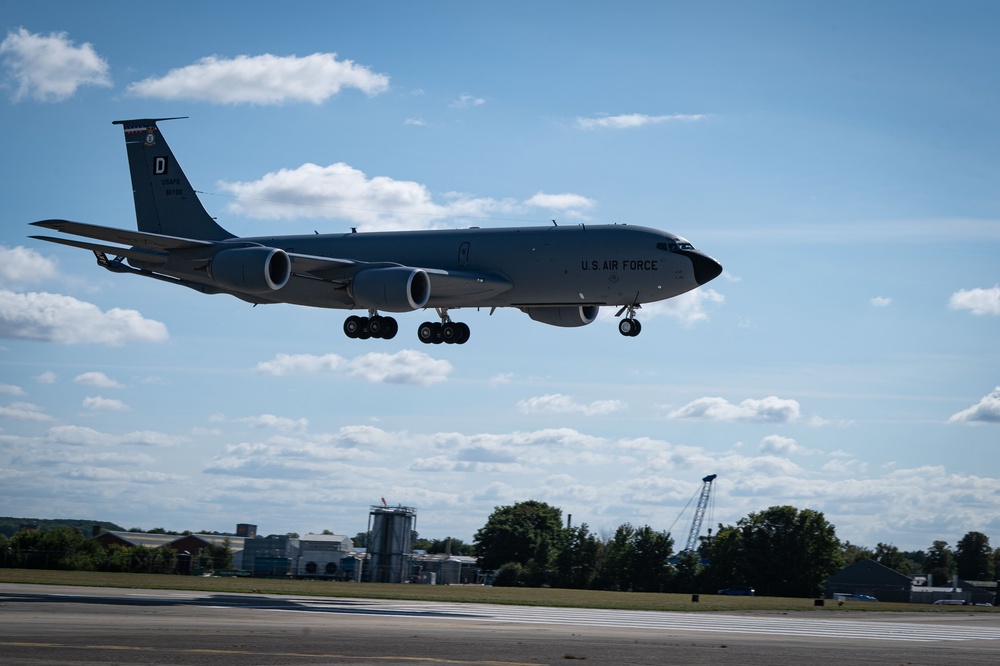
[114,118,233,240]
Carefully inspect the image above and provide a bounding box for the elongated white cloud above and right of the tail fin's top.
[128,53,389,104]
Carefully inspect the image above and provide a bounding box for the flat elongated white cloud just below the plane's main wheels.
[257,349,452,386]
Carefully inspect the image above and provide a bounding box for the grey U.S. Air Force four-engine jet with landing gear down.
[31,118,722,344]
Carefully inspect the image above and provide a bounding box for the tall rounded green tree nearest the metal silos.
[473,500,563,585]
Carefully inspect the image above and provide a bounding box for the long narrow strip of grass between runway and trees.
[0,569,994,613]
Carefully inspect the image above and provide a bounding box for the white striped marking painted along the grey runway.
[238,598,1000,643]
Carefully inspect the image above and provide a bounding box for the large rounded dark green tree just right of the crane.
[709,506,844,597]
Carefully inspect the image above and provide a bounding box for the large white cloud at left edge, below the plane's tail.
[0,289,168,346]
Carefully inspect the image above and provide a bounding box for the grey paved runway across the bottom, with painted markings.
[0,584,1000,665]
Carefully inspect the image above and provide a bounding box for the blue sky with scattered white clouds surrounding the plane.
[0,0,1000,549]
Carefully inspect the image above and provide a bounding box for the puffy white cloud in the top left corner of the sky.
[0,28,111,102]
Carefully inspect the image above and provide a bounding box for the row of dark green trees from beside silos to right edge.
[473,500,1000,597]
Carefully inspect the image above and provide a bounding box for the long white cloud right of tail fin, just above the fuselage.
[218,162,519,230]
